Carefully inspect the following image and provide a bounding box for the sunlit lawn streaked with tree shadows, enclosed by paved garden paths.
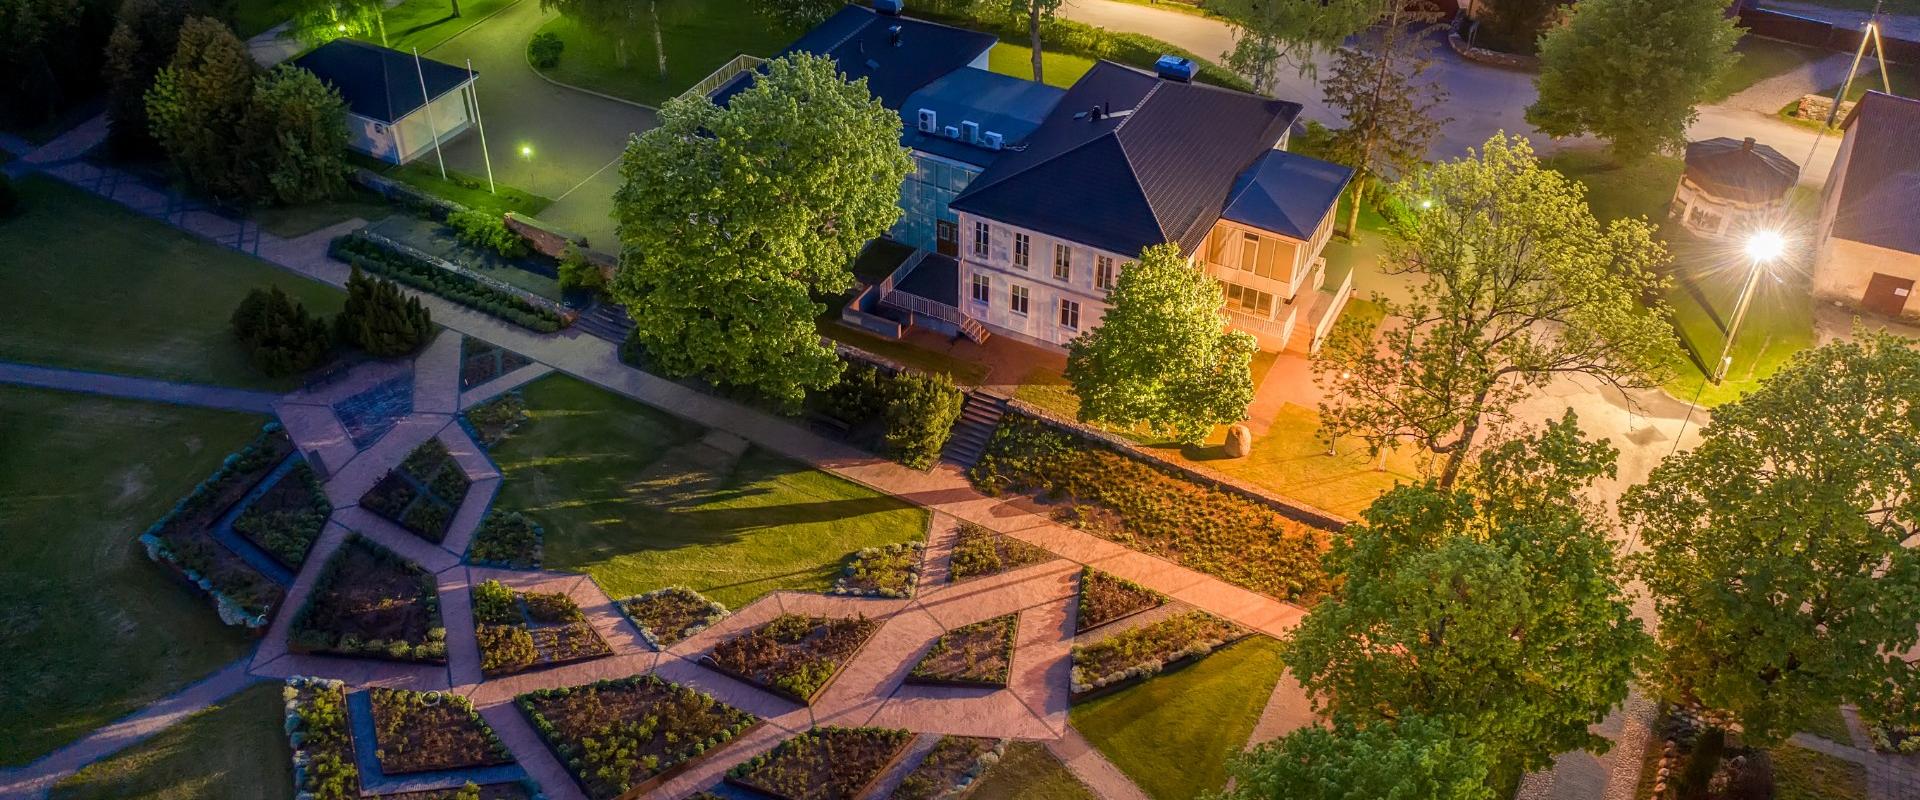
[492,376,927,608]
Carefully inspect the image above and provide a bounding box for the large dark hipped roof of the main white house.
[950,61,1300,255]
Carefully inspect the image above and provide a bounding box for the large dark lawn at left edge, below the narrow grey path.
[0,388,265,767]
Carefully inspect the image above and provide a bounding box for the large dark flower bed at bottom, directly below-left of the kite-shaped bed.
[516,673,760,800]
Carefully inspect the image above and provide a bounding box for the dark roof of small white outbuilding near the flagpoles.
[294,38,468,125]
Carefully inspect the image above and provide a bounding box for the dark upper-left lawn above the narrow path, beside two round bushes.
[0,178,344,389]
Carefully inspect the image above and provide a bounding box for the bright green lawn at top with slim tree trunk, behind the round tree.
[540,0,799,106]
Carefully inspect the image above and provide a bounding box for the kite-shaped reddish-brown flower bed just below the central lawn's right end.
[703,614,879,704]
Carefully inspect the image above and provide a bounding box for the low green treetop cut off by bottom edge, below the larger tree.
[1221,716,1494,800]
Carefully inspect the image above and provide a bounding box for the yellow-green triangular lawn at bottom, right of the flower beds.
[1071,637,1283,800]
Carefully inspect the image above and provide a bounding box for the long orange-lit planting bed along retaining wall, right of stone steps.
[968,416,1329,602]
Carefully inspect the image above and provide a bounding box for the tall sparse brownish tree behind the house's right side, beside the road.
[1321,4,1446,238]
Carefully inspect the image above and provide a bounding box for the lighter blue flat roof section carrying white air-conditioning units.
[900,67,1068,167]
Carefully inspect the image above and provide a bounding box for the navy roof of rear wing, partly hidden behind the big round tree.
[710,6,995,111]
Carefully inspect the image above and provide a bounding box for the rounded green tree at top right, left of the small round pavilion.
[1526,0,1740,161]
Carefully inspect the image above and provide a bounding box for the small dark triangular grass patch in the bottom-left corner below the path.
[50,681,294,800]
